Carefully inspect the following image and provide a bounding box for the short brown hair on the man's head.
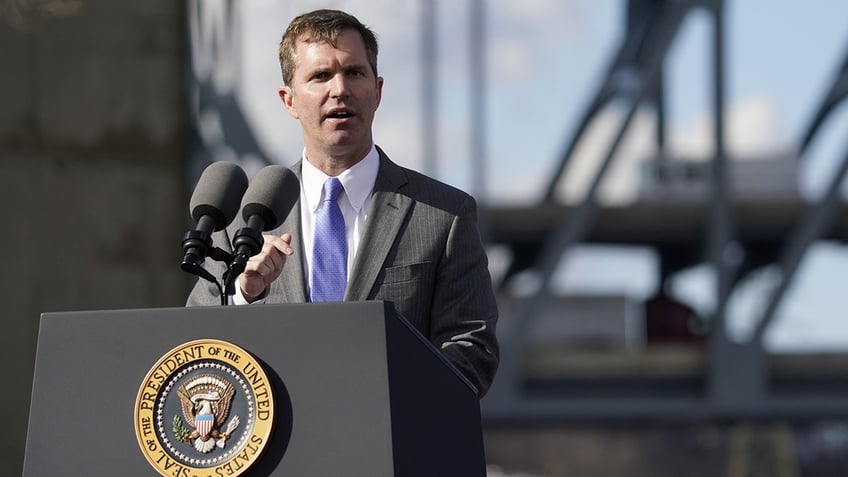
[280,9,378,85]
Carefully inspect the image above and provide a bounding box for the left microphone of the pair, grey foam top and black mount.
[182,162,247,274]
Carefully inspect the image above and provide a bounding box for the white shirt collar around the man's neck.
[301,144,380,212]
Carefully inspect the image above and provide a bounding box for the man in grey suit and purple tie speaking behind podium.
[188,10,498,397]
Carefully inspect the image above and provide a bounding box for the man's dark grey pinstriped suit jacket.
[187,149,498,397]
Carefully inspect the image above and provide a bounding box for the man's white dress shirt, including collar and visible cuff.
[232,144,380,305]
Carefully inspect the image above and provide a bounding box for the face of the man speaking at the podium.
[279,30,383,165]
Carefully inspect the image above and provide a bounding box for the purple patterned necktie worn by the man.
[310,177,347,302]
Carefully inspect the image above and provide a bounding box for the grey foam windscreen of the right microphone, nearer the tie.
[241,165,300,230]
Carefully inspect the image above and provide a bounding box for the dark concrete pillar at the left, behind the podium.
[0,0,189,475]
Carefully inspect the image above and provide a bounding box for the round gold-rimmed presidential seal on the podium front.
[134,339,274,477]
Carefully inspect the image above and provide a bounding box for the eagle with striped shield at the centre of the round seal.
[173,374,239,453]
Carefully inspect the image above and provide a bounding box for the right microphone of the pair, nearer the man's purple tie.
[230,165,300,279]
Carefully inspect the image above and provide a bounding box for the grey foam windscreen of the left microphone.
[189,161,247,231]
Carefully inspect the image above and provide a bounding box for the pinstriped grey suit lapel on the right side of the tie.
[345,152,413,301]
